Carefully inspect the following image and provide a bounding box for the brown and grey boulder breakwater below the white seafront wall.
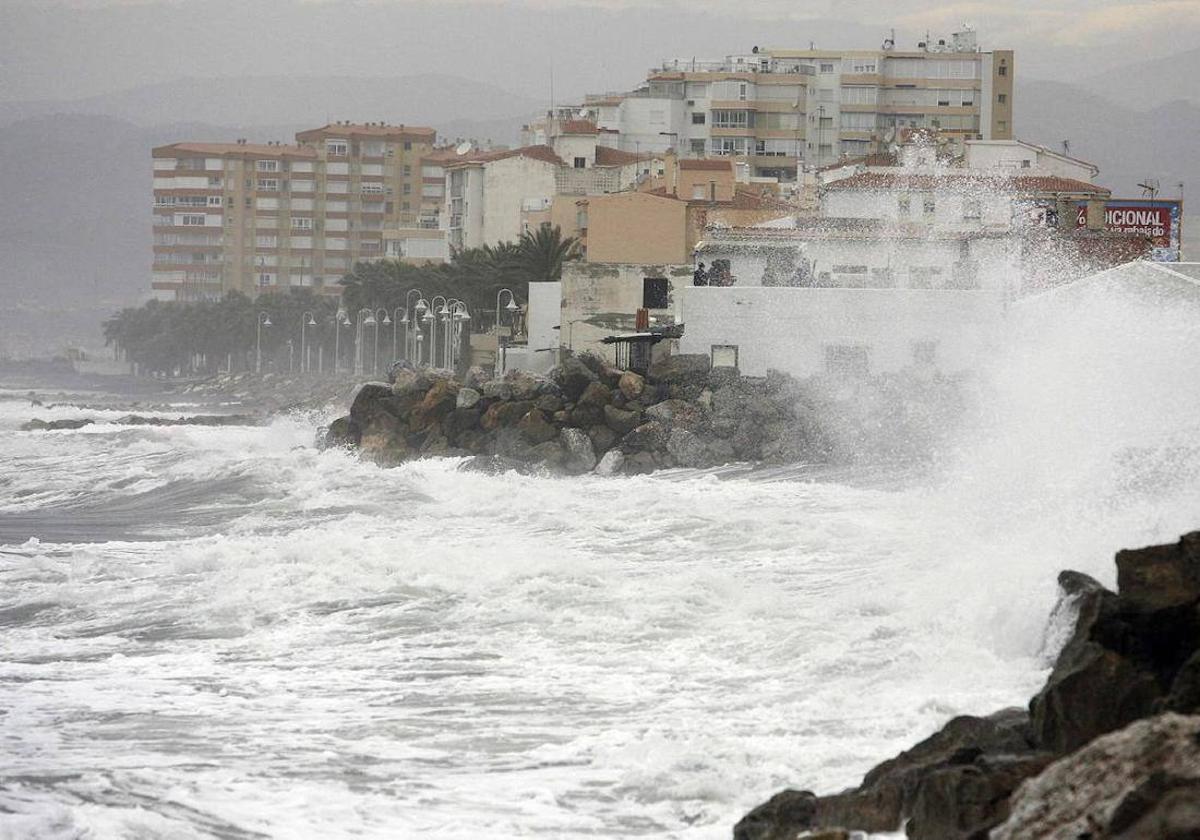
[323,355,828,475]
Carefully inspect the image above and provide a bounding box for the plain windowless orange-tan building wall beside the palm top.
[588,192,691,264]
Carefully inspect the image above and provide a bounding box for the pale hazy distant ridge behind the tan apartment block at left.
[0,74,542,143]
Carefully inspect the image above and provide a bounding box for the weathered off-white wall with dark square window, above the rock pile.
[556,262,692,361]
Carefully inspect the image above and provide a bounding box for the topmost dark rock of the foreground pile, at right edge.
[1117,532,1200,610]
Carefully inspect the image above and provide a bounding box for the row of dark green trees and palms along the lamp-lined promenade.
[103,224,581,376]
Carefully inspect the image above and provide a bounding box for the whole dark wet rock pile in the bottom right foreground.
[733,532,1200,840]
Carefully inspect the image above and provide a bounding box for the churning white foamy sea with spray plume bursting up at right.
[0,278,1200,839]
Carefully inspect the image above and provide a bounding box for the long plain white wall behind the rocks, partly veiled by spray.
[674,287,1003,377]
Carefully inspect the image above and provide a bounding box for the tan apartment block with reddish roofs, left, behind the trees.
[151,122,443,300]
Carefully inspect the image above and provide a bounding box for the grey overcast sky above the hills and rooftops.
[0,0,1200,101]
